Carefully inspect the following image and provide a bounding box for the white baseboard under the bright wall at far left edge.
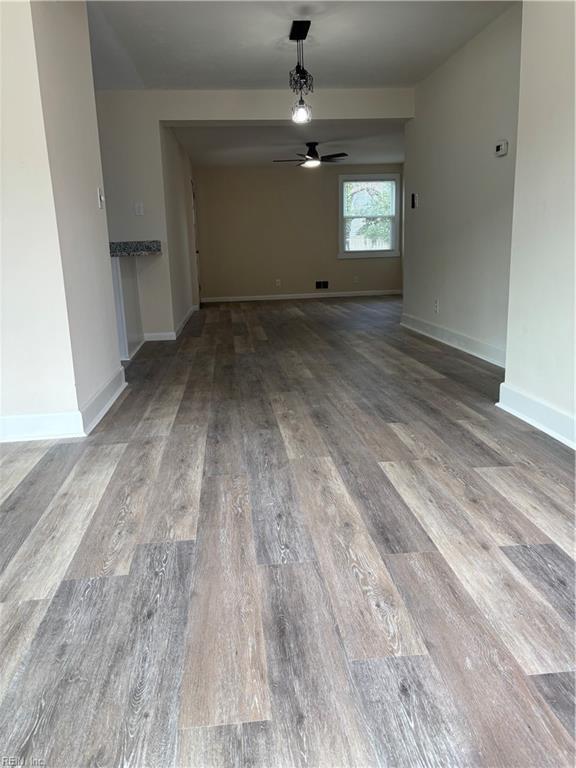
[0,411,85,443]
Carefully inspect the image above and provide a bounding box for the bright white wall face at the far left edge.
[0,3,78,434]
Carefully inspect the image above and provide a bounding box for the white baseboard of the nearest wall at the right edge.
[496,382,576,448]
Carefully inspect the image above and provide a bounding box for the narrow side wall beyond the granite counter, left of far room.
[161,126,196,331]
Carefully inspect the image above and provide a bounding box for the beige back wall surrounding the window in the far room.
[194,165,402,299]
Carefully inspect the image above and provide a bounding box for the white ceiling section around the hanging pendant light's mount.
[88,0,510,89]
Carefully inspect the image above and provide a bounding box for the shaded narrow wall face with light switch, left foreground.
[32,2,120,420]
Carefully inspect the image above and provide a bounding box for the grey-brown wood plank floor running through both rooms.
[0,298,575,768]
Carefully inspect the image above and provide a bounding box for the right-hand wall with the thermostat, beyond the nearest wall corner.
[404,6,521,365]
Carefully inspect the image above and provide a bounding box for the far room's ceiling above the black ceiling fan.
[174,120,404,166]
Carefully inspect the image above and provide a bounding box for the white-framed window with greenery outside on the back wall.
[339,174,400,259]
